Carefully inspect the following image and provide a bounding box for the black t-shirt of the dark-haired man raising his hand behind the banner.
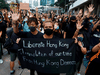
[16,31,43,38]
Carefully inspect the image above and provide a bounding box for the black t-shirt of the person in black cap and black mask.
[64,24,76,38]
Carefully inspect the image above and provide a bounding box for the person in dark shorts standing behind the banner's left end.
[8,25,21,75]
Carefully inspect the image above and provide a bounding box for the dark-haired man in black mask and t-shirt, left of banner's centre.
[14,18,42,38]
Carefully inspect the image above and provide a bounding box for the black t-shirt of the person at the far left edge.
[0,21,7,43]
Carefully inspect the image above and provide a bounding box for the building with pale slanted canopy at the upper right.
[69,0,100,17]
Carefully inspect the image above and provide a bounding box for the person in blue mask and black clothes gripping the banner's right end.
[76,31,87,75]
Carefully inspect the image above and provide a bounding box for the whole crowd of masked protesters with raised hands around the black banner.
[0,4,100,75]
